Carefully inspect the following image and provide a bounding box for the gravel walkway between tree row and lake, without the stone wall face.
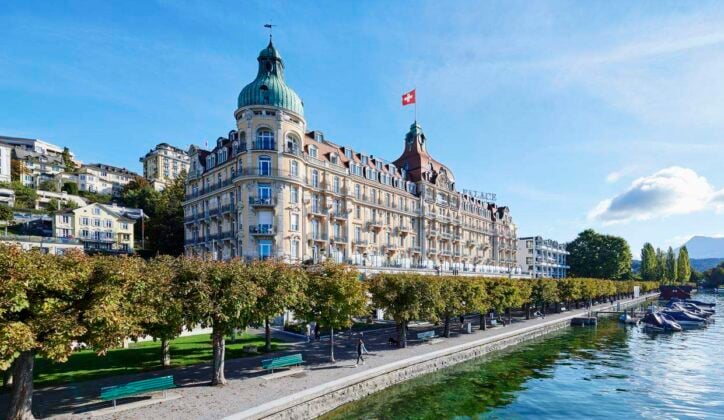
[0,296,652,419]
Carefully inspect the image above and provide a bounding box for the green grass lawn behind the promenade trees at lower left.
[34,333,284,387]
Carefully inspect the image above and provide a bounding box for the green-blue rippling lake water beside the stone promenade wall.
[325,295,724,419]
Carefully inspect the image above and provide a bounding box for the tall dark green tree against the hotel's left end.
[146,172,186,255]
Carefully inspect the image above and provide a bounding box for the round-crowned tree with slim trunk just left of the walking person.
[299,261,367,362]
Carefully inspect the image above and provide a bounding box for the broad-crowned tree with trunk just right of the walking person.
[369,274,439,348]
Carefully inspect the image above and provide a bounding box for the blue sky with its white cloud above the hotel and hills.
[0,1,724,255]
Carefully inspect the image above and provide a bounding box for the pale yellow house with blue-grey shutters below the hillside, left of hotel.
[53,203,142,253]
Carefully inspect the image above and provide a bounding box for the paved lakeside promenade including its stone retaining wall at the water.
[0,294,655,419]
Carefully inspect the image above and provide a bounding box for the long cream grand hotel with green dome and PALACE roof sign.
[184,41,519,275]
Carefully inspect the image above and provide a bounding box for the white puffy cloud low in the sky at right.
[588,166,724,223]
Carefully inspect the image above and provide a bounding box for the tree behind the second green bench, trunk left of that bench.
[248,259,306,351]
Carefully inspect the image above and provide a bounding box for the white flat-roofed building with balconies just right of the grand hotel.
[517,236,570,279]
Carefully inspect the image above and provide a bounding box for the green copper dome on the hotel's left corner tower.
[238,40,304,116]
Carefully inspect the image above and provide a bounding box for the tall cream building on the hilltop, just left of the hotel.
[139,143,189,191]
